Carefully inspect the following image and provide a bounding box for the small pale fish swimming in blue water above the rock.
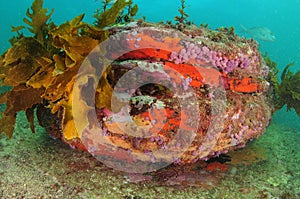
[241,25,276,41]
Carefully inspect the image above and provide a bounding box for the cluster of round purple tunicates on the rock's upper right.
[170,42,250,73]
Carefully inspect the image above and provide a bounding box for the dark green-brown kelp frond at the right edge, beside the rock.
[276,63,300,116]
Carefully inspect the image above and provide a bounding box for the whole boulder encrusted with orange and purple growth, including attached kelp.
[0,0,300,172]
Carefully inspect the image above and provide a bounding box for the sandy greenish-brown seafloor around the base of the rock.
[0,113,300,199]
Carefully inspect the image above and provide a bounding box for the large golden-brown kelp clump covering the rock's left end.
[0,0,129,139]
